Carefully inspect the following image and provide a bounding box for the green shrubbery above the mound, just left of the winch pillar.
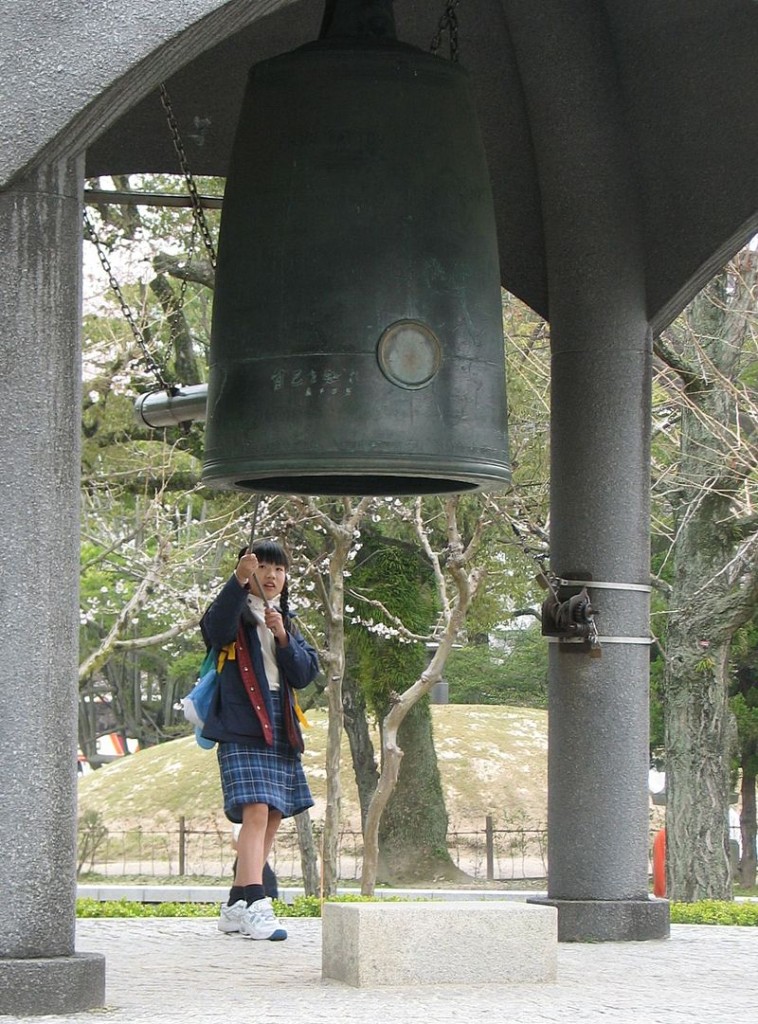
[445,625,547,708]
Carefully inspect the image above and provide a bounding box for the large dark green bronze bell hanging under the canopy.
[203,0,510,496]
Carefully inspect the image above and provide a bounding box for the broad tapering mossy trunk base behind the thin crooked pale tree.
[377,697,468,885]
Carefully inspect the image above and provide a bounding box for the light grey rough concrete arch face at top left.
[0,0,293,188]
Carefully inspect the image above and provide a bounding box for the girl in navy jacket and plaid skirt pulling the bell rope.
[201,541,319,941]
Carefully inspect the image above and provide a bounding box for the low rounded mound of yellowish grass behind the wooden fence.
[79,705,547,833]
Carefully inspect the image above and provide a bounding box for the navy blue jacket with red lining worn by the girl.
[200,575,319,750]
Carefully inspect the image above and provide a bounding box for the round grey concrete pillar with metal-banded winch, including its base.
[514,0,669,941]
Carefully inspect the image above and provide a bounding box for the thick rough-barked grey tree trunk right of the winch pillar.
[663,253,756,902]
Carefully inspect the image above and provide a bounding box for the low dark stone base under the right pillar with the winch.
[527,896,670,942]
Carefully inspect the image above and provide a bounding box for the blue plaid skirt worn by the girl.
[218,690,313,823]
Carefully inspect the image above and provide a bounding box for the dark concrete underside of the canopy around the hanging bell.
[87,0,758,330]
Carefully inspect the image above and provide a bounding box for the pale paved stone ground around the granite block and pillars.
[8,918,758,1024]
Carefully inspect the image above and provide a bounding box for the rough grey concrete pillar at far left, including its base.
[0,160,104,1016]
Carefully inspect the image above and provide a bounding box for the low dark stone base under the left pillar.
[0,953,106,1017]
